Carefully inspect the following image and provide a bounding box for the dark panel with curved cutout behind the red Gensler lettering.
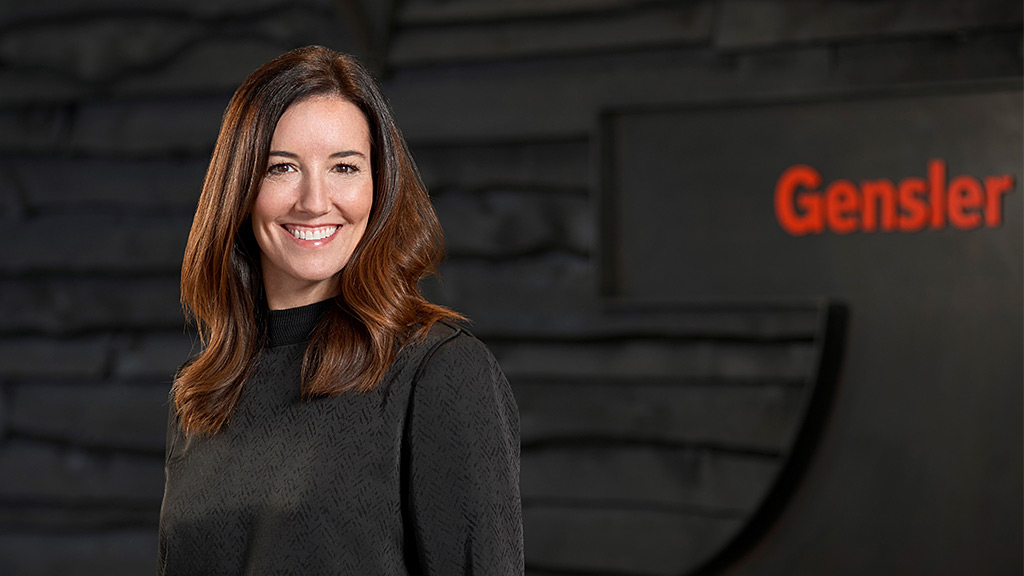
[602,80,1024,575]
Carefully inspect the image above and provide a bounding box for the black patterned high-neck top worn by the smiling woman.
[159,302,523,576]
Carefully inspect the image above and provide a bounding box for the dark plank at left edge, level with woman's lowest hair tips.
[9,382,169,456]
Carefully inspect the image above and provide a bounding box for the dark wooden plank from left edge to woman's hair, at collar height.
[0,276,184,334]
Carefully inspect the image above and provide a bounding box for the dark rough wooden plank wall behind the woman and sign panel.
[0,0,1022,575]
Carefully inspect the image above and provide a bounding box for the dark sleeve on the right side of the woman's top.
[407,333,523,576]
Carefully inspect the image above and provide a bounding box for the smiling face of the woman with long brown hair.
[252,95,374,310]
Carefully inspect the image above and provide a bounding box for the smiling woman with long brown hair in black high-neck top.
[160,46,523,575]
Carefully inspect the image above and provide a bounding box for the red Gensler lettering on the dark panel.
[775,159,1014,236]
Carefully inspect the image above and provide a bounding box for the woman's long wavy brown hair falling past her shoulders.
[174,46,462,434]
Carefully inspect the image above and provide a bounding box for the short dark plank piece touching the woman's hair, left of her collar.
[114,331,199,379]
